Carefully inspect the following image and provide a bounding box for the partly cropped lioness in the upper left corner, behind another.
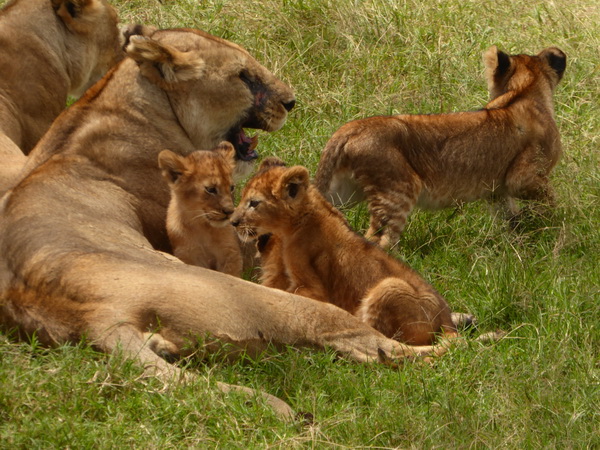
[0,0,140,195]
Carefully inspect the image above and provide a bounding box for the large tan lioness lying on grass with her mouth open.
[0,29,437,422]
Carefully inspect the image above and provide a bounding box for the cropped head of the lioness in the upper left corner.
[49,0,125,97]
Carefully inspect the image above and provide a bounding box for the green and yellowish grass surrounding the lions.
[0,0,600,448]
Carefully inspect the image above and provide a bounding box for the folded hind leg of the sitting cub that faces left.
[356,278,457,345]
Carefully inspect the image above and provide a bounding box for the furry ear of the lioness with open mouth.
[125,35,205,89]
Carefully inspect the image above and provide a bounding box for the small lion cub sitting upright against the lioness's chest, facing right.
[158,141,242,277]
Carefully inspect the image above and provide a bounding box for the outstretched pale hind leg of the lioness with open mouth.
[72,250,442,362]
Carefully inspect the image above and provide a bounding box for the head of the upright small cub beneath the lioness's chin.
[158,142,235,227]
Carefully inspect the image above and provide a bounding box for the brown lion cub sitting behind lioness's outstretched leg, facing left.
[231,158,457,345]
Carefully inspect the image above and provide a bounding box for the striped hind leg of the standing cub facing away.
[359,164,422,248]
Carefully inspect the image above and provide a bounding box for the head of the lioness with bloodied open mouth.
[127,29,295,176]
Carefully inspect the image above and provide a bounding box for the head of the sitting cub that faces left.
[231,158,309,241]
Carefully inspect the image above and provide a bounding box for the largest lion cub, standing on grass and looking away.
[315,46,566,247]
